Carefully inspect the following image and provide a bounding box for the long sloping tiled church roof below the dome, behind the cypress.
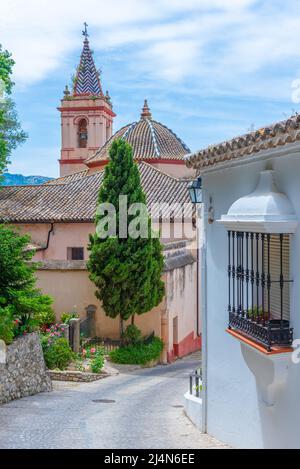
[0,162,192,223]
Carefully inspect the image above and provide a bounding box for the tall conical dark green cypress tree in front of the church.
[88,139,164,334]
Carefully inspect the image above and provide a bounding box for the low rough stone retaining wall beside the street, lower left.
[0,334,51,404]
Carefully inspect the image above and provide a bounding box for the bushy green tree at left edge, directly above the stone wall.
[0,225,52,338]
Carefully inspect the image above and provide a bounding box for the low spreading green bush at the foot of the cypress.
[109,337,164,365]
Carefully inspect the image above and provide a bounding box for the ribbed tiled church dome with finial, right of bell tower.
[86,101,190,166]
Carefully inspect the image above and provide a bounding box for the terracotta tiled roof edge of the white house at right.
[185,115,300,171]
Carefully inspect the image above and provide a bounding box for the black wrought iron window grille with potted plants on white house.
[228,231,293,350]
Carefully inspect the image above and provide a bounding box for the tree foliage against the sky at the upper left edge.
[0,45,27,174]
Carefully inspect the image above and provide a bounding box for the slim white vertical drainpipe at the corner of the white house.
[198,191,207,433]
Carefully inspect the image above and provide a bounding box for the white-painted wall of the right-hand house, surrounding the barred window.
[201,144,300,448]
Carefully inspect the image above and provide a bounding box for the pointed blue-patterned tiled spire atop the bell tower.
[73,23,103,96]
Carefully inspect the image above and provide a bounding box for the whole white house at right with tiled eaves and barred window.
[186,116,300,448]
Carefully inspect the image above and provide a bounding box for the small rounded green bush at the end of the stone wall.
[42,338,75,370]
